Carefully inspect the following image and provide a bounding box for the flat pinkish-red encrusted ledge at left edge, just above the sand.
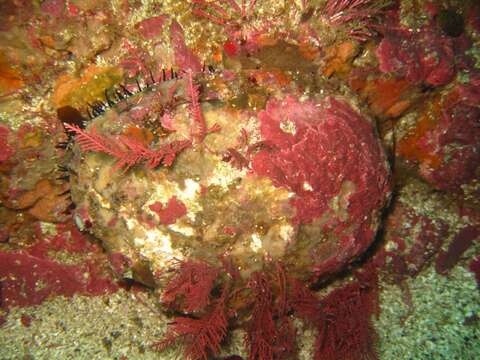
[0,222,118,309]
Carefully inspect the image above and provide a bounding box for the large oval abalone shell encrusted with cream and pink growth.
[69,69,390,288]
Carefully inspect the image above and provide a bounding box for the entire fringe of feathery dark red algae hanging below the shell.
[156,263,379,360]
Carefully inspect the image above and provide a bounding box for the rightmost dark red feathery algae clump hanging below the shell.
[288,261,380,360]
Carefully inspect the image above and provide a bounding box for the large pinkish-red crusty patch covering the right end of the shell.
[252,97,388,223]
